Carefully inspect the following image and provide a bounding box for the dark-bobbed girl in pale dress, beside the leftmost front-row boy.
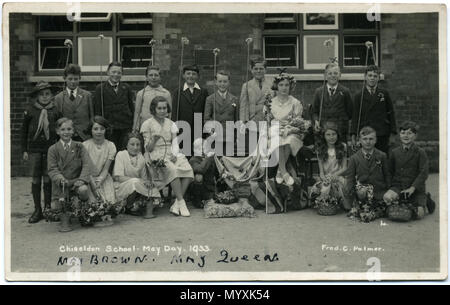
[83,116,117,204]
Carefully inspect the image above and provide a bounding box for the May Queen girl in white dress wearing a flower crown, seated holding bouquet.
[269,73,304,185]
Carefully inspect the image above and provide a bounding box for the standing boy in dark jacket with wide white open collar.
[172,65,209,155]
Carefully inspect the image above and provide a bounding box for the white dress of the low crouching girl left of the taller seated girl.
[113,150,161,201]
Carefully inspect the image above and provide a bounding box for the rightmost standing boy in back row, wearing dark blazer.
[350,65,397,154]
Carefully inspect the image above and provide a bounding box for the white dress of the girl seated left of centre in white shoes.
[141,118,194,189]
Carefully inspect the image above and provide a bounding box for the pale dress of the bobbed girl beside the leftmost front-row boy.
[83,139,117,203]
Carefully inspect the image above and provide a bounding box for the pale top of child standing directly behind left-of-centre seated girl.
[133,85,172,130]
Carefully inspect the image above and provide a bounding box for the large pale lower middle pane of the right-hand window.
[303,35,339,69]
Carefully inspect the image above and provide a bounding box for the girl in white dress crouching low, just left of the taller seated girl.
[113,132,161,218]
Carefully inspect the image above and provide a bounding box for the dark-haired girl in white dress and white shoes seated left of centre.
[141,96,194,216]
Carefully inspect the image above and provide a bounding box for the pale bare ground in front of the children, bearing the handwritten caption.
[7,174,439,272]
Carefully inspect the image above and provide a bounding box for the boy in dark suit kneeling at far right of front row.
[384,121,428,219]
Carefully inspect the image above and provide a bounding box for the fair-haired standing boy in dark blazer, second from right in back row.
[313,63,353,143]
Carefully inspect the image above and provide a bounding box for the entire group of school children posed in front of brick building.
[21,54,428,230]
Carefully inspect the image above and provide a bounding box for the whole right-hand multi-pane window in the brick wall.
[263,13,379,72]
